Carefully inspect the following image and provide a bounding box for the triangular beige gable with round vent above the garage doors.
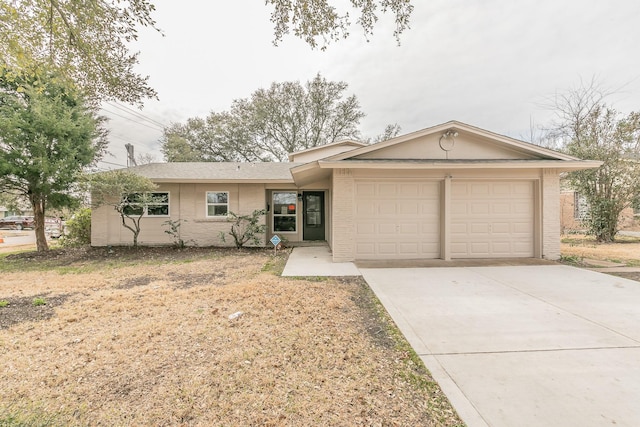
[327,121,578,161]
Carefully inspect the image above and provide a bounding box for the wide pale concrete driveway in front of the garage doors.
[360,265,640,427]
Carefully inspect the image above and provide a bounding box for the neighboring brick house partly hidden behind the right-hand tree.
[560,187,640,233]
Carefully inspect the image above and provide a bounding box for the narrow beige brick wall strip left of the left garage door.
[331,169,355,262]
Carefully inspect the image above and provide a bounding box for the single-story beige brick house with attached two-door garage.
[91,121,601,262]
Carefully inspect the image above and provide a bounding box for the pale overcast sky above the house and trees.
[96,0,640,168]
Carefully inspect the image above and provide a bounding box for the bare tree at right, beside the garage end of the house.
[548,80,640,242]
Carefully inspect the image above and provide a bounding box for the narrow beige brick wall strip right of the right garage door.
[541,169,560,260]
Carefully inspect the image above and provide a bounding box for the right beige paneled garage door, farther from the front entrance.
[451,181,534,258]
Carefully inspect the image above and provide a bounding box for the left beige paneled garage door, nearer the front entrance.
[355,180,440,259]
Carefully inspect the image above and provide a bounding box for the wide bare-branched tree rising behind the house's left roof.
[162,74,365,161]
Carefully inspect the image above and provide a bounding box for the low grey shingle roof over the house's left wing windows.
[128,162,302,182]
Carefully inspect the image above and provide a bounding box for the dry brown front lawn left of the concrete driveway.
[0,248,462,426]
